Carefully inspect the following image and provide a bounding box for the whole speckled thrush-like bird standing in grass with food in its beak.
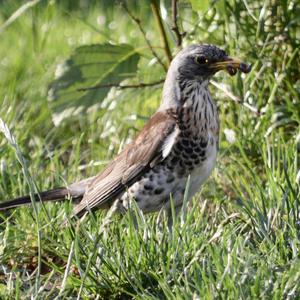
[0,44,251,223]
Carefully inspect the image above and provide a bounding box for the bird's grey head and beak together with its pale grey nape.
[159,44,251,110]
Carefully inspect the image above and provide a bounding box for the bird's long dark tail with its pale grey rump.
[0,178,93,211]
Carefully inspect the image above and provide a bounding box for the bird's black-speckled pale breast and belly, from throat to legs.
[120,83,219,212]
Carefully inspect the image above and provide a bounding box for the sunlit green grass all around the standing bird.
[0,1,300,299]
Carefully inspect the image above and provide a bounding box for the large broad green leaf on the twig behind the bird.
[48,44,140,125]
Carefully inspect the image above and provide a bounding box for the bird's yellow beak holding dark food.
[212,56,251,76]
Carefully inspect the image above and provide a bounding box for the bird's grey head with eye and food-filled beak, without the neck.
[170,45,251,81]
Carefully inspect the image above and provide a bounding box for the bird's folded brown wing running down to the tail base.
[74,111,178,215]
